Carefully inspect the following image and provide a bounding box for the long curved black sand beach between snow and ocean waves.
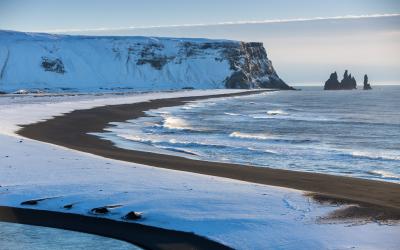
[18,91,400,210]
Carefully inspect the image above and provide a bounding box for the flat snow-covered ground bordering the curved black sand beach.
[0,91,400,249]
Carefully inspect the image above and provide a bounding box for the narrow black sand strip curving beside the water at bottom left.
[0,206,231,249]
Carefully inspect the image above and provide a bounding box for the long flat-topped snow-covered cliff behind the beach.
[0,31,290,92]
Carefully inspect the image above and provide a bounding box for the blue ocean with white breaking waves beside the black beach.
[98,86,400,183]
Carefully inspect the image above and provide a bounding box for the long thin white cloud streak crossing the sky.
[45,13,400,33]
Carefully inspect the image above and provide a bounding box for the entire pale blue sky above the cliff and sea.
[0,0,400,85]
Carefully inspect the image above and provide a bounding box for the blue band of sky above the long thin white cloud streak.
[0,0,400,31]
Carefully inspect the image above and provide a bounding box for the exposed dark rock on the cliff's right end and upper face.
[131,41,293,90]
